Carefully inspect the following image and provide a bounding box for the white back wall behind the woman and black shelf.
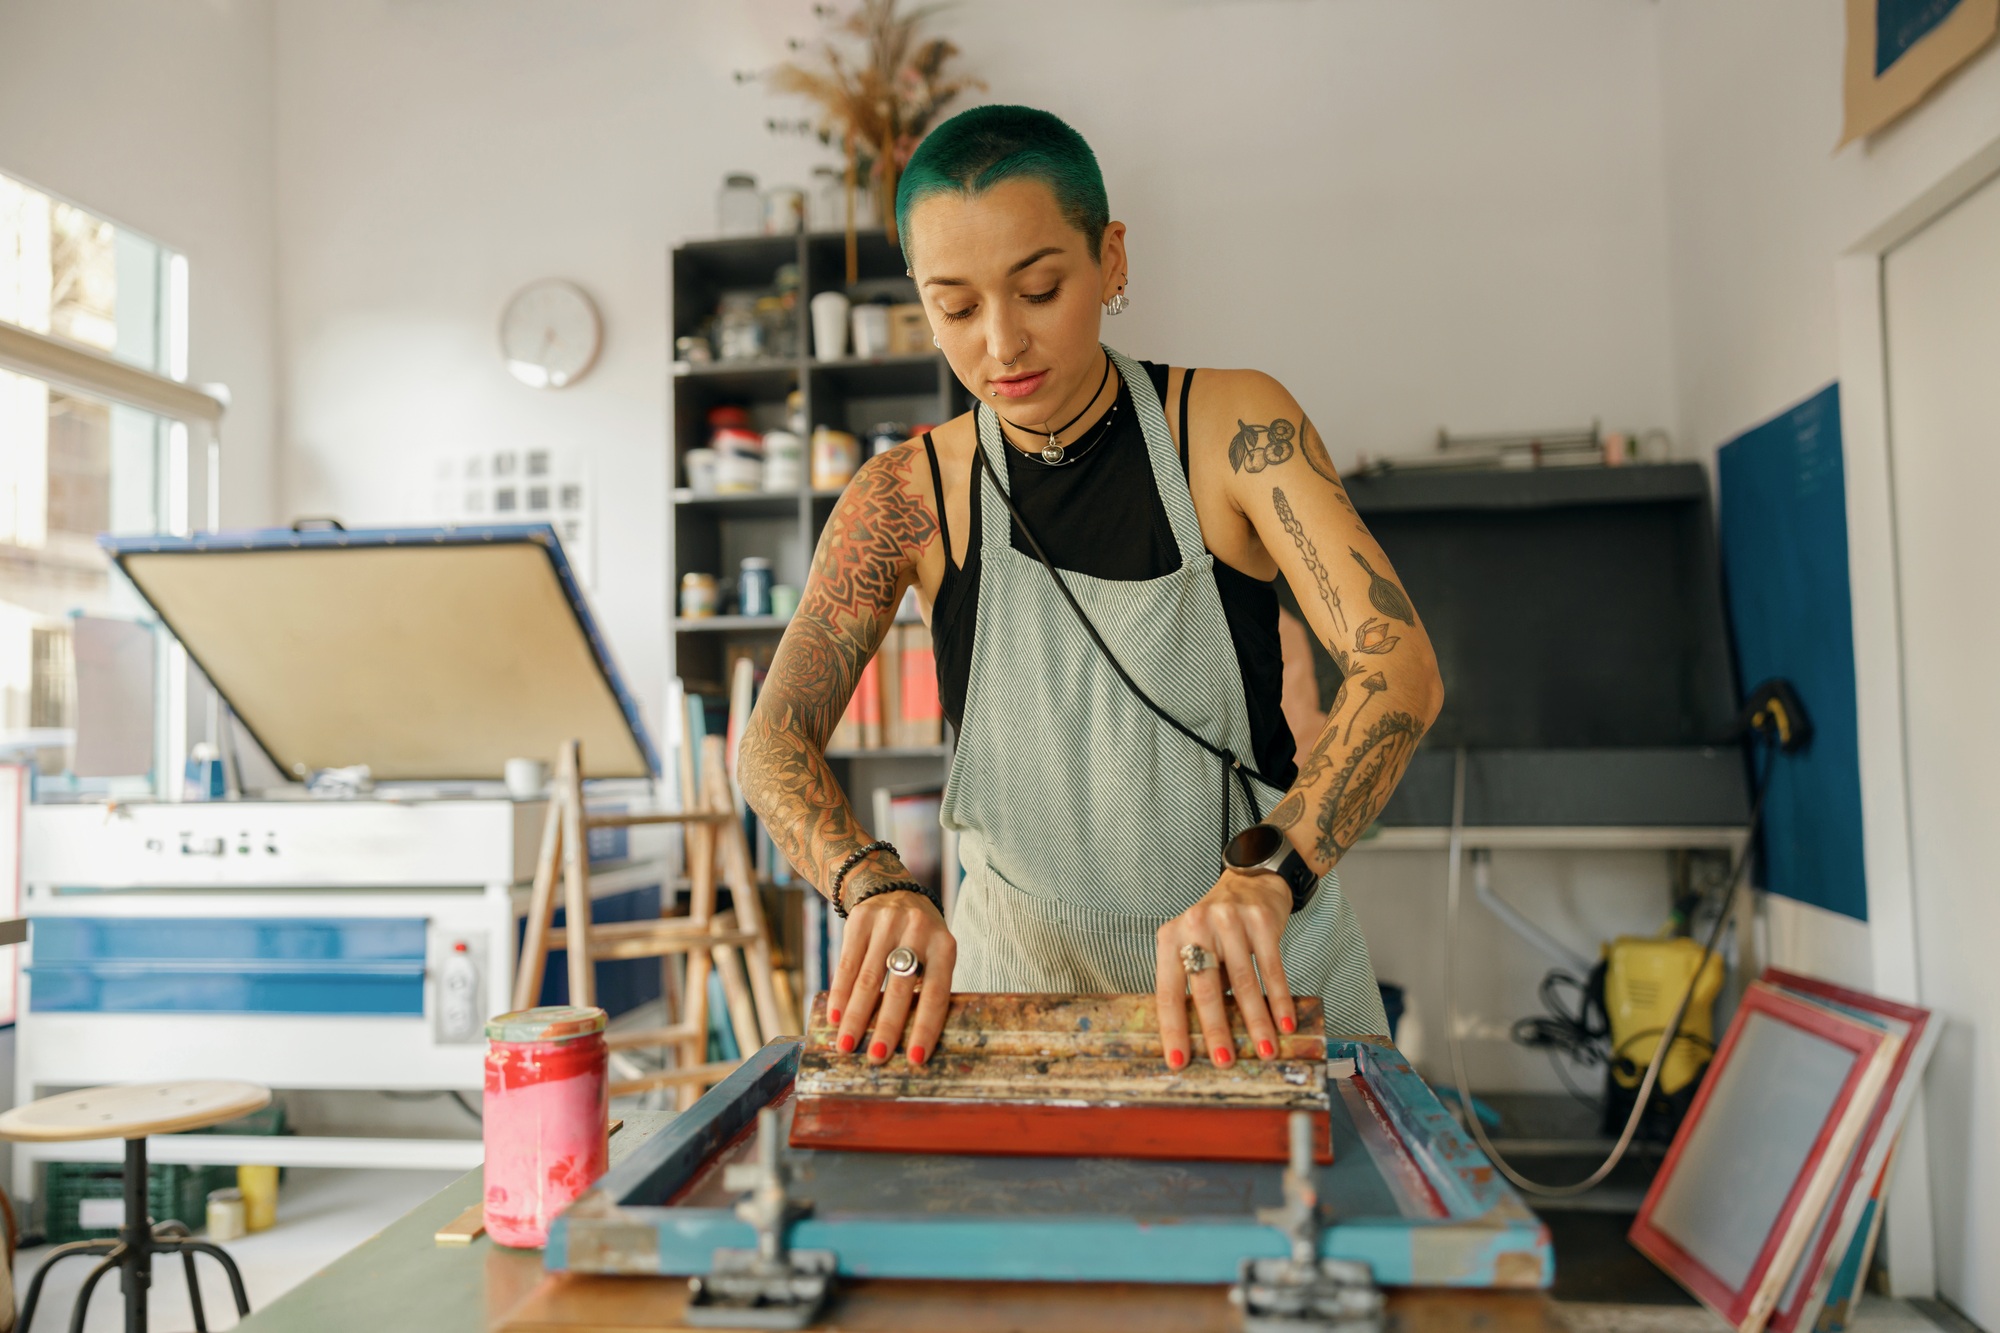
[276,0,1676,1087]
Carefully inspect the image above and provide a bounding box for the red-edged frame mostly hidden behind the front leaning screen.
[1762,967,1944,1333]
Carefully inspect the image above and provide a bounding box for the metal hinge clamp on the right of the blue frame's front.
[1230,1111,1382,1333]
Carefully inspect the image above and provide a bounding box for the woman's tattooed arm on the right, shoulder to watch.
[1230,372,1444,873]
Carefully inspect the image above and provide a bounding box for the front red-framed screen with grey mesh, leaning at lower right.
[1630,981,1902,1333]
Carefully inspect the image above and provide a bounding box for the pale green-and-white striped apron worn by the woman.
[942,348,1388,1033]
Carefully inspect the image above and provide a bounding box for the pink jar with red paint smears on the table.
[482,1005,610,1249]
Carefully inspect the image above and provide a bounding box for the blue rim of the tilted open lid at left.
[98,522,660,781]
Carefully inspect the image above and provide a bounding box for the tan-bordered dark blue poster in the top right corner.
[1840,0,2000,146]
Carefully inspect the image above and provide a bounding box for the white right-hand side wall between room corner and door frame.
[1660,0,2000,987]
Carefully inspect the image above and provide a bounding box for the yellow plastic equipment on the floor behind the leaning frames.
[1604,935,1722,1097]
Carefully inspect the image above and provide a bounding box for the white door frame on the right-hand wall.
[1834,138,2000,1297]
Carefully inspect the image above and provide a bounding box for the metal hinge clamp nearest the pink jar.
[686,1107,838,1329]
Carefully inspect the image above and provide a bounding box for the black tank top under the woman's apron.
[924,360,1298,787]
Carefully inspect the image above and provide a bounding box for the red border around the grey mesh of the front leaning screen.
[1628,981,1902,1333]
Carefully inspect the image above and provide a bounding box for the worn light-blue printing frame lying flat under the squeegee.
[544,1039,1554,1289]
